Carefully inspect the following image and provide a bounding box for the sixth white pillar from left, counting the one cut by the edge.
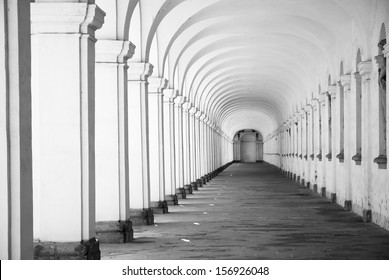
[163,89,177,204]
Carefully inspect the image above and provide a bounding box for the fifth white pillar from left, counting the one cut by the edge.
[148,77,168,213]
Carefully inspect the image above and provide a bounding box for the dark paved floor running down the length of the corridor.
[101,163,389,260]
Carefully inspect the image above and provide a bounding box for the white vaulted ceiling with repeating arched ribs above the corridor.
[97,0,378,138]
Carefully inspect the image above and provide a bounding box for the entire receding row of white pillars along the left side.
[0,0,232,259]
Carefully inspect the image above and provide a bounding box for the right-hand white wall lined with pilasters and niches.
[265,40,389,229]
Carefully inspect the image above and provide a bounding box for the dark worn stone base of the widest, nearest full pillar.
[34,238,101,260]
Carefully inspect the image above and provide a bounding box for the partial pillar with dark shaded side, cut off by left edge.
[0,0,33,260]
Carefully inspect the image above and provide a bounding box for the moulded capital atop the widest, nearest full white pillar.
[31,3,105,36]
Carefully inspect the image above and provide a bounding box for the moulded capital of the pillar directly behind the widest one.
[96,40,135,63]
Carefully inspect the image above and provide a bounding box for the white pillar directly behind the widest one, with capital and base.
[95,40,135,242]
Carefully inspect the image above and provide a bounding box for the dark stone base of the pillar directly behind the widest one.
[96,220,134,244]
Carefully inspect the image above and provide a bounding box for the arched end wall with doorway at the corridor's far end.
[234,129,263,162]
